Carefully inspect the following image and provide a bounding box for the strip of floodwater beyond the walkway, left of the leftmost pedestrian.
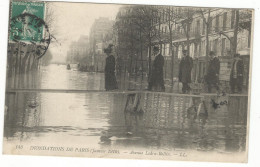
[6,64,104,90]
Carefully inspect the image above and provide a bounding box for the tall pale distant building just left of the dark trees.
[89,17,114,72]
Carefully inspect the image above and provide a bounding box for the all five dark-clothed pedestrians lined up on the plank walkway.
[104,45,244,93]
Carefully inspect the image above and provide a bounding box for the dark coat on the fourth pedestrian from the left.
[205,57,220,84]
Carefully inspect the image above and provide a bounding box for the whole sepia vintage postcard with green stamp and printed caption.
[3,0,254,163]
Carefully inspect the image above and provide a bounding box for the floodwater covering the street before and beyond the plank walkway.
[4,65,247,153]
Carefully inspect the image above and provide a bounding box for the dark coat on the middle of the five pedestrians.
[179,56,193,83]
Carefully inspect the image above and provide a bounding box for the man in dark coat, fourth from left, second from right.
[205,51,220,93]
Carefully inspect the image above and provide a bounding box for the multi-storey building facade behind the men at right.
[153,7,252,89]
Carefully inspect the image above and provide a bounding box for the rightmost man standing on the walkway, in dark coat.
[230,54,244,93]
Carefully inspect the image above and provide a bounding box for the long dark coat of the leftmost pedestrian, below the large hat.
[105,55,118,90]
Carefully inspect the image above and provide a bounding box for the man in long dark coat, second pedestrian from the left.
[148,46,165,91]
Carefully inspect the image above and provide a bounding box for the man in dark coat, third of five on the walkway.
[179,50,193,93]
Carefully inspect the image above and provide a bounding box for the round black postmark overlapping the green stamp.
[9,13,51,59]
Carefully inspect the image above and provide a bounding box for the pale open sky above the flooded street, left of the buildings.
[49,2,121,61]
